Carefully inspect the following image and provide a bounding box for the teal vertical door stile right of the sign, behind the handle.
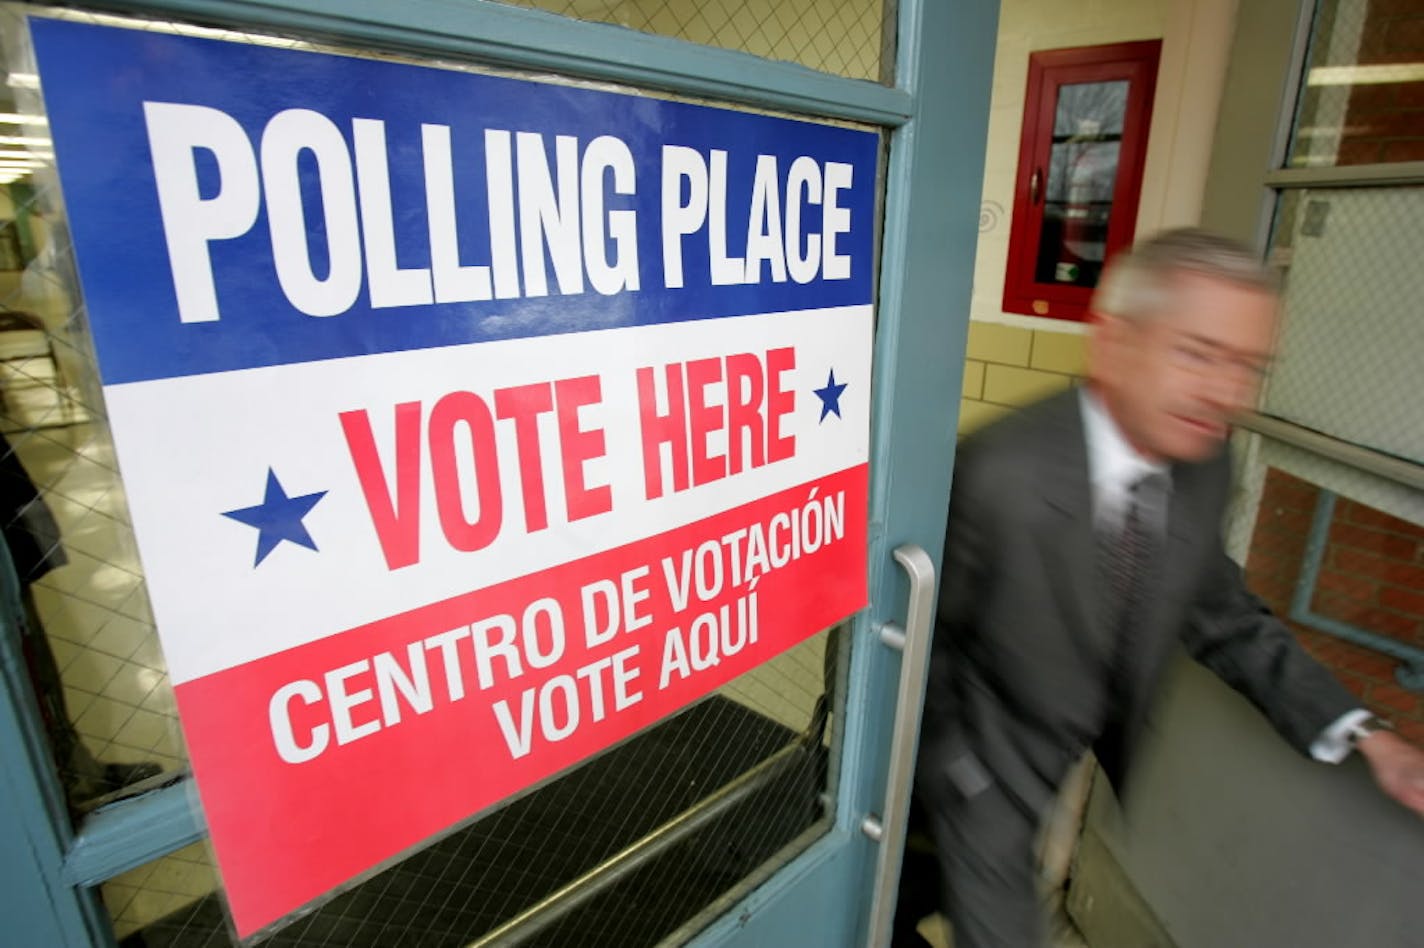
[692,0,998,947]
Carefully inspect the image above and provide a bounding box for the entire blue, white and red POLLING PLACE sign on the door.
[30,19,877,937]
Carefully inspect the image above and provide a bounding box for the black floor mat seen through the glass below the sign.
[121,696,826,948]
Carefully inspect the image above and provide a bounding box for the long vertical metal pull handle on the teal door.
[860,544,936,948]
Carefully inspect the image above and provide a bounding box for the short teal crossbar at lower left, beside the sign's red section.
[63,779,208,885]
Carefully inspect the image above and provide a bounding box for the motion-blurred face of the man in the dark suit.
[1088,273,1277,461]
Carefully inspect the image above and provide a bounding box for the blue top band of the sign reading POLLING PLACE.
[30,19,877,384]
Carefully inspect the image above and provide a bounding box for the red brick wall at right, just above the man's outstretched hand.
[1246,468,1424,743]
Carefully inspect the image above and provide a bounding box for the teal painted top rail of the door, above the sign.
[66,0,910,127]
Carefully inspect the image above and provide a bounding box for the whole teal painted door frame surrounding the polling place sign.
[0,0,998,945]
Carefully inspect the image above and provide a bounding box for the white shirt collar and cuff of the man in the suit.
[1079,386,1370,763]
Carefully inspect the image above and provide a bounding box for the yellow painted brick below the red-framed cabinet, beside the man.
[958,320,1087,436]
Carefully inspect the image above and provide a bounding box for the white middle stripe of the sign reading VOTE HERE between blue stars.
[105,306,871,682]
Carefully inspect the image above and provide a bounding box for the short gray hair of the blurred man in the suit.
[1092,228,1280,322]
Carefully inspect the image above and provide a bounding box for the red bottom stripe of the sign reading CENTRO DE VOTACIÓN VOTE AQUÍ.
[177,464,867,937]
